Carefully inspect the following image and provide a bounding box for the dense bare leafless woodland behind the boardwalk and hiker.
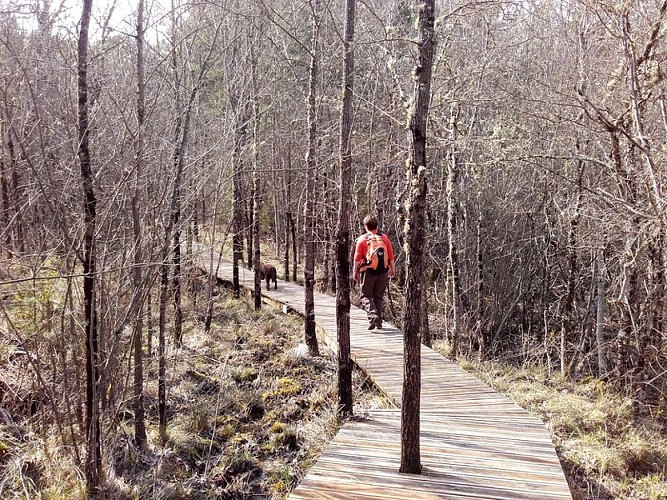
[0,0,667,498]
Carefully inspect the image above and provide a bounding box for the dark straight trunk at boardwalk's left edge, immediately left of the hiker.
[336,0,356,416]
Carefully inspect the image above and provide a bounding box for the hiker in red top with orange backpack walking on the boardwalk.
[353,215,396,330]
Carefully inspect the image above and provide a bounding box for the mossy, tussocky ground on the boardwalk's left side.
[0,292,388,500]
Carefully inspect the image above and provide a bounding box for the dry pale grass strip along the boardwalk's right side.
[435,343,667,500]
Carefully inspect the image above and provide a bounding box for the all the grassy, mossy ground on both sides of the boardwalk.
[0,270,667,500]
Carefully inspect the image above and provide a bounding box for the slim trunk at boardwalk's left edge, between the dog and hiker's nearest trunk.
[303,0,320,356]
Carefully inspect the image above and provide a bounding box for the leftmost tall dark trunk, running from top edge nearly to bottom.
[78,0,103,488]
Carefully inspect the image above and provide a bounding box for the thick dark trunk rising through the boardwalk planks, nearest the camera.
[399,0,435,474]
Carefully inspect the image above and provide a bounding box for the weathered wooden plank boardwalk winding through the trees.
[190,244,572,500]
